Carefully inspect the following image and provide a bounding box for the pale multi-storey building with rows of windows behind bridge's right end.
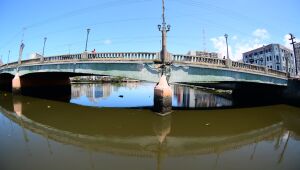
[243,44,296,75]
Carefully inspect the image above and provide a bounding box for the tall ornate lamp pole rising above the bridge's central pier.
[158,0,171,64]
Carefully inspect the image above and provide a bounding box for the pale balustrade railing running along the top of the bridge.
[0,52,287,77]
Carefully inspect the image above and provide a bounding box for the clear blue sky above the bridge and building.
[0,0,300,63]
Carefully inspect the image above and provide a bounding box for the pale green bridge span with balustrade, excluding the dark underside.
[0,52,287,86]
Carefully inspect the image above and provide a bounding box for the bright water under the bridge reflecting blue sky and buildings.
[71,82,232,108]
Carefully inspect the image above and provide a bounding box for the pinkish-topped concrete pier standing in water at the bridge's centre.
[153,75,172,116]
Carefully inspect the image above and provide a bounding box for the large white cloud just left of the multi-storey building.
[210,29,270,61]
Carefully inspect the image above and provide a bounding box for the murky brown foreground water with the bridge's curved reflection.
[0,90,300,169]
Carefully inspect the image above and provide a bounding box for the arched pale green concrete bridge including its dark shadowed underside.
[0,52,298,115]
